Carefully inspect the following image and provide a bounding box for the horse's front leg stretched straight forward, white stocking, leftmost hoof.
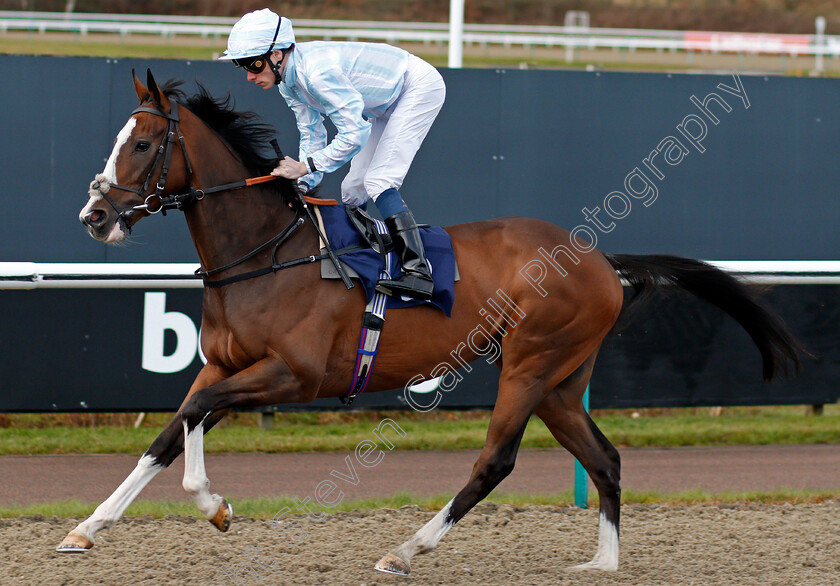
[56,366,227,553]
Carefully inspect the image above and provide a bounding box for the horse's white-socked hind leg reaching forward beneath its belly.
[374,372,545,575]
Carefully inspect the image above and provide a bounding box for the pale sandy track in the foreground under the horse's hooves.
[6,500,840,586]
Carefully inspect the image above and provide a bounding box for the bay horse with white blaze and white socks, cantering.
[58,72,800,575]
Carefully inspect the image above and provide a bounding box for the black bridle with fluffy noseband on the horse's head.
[99,98,195,227]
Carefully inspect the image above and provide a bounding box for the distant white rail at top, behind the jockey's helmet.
[0,11,840,57]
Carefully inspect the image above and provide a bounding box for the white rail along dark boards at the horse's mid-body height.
[0,260,840,289]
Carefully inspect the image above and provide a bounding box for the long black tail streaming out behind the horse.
[606,254,804,381]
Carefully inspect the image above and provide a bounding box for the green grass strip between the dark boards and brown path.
[0,404,840,455]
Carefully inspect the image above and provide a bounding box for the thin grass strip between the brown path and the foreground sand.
[0,490,838,519]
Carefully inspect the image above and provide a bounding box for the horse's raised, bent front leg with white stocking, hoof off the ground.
[181,358,311,531]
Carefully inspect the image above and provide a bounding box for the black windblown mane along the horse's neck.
[160,79,293,201]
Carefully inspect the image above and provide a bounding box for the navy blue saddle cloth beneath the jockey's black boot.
[318,204,455,317]
